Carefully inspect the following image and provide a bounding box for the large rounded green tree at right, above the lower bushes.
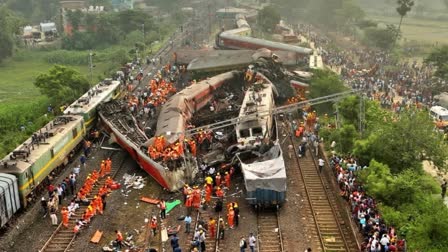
[353,111,448,174]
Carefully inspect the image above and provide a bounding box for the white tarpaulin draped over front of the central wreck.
[241,144,286,192]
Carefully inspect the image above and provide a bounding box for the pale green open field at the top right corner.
[369,15,448,44]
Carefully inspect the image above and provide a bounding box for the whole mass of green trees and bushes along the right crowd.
[322,93,448,251]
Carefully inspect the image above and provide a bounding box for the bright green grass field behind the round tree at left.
[0,51,118,104]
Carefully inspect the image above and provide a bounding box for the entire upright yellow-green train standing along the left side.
[0,80,121,228]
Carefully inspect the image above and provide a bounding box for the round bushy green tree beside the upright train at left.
[34,65,89,106]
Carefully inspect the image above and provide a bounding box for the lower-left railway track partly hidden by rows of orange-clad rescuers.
[39,152,127,252]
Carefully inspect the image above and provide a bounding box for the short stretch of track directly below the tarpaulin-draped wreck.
[256,211,285,252]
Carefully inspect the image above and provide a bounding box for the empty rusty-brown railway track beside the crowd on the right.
[290,136,359,251]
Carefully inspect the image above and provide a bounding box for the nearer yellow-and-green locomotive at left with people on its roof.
[0,116,86,207]
